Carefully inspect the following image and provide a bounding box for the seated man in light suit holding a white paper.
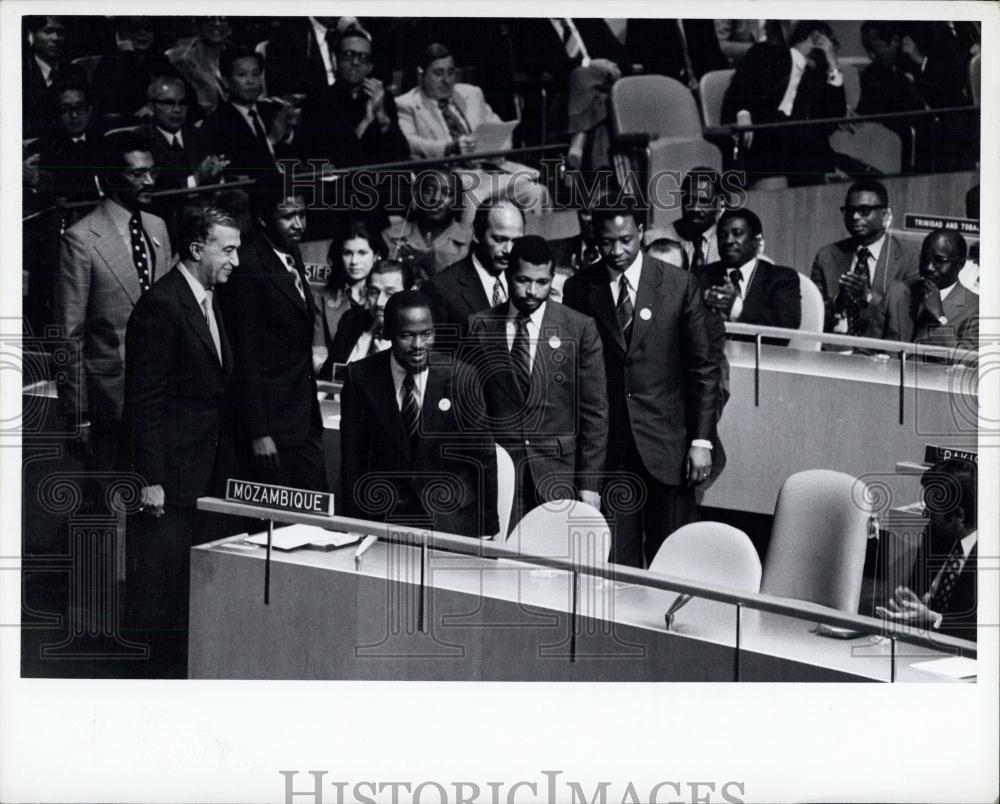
[396,43,549,219]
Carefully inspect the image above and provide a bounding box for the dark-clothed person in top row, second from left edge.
[92,17,176,121]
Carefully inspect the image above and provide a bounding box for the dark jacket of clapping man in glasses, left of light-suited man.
[296,82,410,168]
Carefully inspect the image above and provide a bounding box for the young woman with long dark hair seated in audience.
[313,220,385,380]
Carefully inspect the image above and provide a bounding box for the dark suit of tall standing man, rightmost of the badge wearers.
[563,243,719,566]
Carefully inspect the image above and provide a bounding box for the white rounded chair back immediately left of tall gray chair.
[649,522,761,628]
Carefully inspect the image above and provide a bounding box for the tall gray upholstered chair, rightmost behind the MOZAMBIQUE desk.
[760,469,872,613]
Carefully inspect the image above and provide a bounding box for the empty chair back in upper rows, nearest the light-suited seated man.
[611,75,702,138]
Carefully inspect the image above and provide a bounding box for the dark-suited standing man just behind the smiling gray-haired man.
[222,187,327,491]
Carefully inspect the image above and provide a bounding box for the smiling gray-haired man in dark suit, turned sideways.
[122,207,240,678]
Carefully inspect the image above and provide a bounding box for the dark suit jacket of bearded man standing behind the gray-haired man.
[219,227,322,449]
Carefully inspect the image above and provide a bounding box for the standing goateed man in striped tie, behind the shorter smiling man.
[469,235,608,524]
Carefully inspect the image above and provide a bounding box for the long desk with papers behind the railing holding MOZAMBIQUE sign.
[190,537,968,681]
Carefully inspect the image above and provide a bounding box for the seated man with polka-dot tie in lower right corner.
[876,458,979,642]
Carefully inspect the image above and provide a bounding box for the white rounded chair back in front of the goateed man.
[508,500,611,564]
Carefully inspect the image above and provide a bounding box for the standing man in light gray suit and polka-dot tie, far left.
[55,131,171,480]
